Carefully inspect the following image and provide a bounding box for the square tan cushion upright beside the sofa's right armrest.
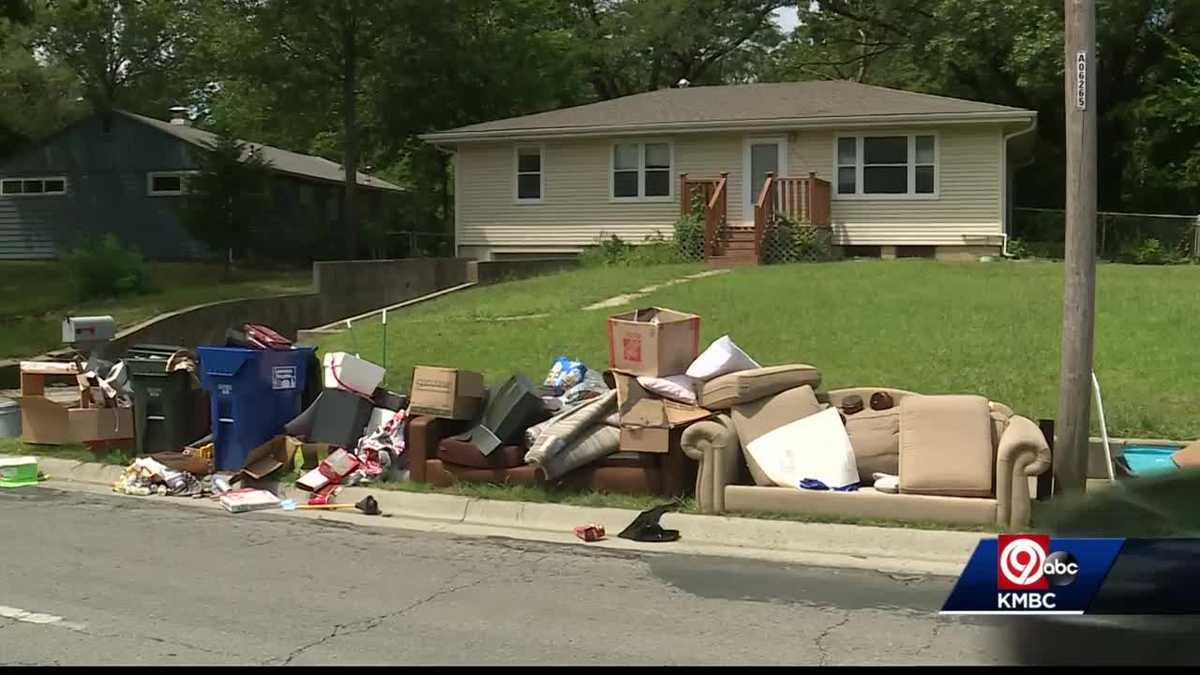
[900,395,996,497]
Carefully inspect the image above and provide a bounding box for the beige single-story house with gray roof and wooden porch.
[422,82,1037,259]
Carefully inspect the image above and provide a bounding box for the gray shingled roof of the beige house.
[421,80,1037,142]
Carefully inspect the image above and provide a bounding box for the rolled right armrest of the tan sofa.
[996,414,1050,528]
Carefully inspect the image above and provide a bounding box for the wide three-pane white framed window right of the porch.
[834,133,940,199]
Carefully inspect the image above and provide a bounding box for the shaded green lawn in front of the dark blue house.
[0,262,312,359]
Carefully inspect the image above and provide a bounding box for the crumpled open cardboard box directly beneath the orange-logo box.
[610,371,713,454]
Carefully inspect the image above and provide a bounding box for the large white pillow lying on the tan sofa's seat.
[745,408,858,490]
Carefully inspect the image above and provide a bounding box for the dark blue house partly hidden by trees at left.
[0,110,404,259]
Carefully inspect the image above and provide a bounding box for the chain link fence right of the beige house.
[1009,208,1200,262]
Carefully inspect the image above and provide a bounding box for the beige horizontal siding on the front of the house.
[455,125,1003,257]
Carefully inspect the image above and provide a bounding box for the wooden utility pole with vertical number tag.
[1054,0,1098,494]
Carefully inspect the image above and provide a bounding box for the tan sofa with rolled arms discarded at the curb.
[682,386,1050,528]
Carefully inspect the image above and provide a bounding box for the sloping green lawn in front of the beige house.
[320,261,1200,438]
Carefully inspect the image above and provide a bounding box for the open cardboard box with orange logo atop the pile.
[608,307,700,377]
